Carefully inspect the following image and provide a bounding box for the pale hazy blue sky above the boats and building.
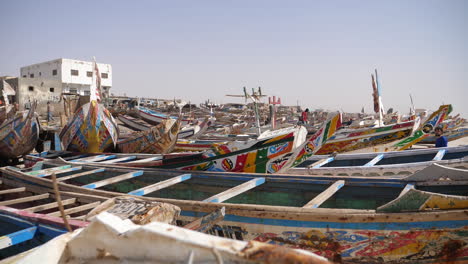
[0,0,468,117]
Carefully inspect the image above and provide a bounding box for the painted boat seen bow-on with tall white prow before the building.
[60,59,119,153]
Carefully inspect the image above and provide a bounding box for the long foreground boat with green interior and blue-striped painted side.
[3,164,468,263]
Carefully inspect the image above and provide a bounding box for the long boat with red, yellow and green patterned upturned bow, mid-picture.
[25,113,341,173]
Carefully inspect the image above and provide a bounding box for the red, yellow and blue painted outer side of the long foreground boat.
[181,211,468,264]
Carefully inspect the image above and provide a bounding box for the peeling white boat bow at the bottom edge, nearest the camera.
[12,212,331,264]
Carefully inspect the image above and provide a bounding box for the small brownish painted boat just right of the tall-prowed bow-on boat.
[117,119,180,154]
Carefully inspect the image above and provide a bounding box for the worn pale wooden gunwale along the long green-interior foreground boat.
[0,168,468,223]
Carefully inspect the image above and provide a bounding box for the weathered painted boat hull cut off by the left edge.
[0,103,39,159]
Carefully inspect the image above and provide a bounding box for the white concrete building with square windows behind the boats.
[17,58,112,114]
